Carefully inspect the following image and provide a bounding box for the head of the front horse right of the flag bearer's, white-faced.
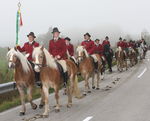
[32,46,45,72]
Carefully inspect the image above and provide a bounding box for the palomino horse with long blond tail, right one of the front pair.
[33,47,80,116]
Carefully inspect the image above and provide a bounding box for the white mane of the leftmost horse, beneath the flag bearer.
[7,48,31,73]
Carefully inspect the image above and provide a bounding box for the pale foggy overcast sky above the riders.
[0,0,150,46]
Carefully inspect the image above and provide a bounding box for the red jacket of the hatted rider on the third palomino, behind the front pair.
[81,40,94,53]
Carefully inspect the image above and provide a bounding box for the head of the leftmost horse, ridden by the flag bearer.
[7,48,18,69]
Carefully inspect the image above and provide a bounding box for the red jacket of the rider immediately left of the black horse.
[89,44,103,56]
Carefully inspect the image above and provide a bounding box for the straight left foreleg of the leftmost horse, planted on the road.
[17,86,26,116]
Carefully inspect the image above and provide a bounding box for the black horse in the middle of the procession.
[103,45,113,72]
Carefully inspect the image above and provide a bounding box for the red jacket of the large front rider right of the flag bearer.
[49,38,67,59]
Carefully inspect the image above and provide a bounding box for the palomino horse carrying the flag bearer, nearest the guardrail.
[7,48,37,115]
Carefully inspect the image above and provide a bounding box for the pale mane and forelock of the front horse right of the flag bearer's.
[32,47,57,68]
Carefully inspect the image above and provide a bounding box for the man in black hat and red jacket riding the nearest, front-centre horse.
[49,27,68,87]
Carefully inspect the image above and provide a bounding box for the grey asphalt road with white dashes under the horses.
[0,52,150,121]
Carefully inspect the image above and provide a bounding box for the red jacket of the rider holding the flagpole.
[17,41,39,61]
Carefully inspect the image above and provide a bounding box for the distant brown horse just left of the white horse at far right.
[128,47,137,66]
